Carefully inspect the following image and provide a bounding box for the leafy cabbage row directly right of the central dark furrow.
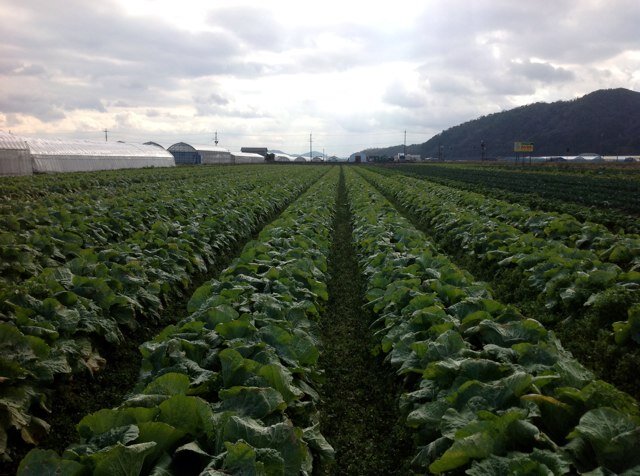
[348,172,640,475]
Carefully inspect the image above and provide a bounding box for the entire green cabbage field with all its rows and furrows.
[0,165,640,475]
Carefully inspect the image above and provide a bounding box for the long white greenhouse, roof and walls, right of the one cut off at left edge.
[26,139,175,173]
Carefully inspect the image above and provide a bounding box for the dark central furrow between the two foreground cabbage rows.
[316,169,413,475]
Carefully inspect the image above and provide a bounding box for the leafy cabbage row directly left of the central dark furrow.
[18,169,338,476]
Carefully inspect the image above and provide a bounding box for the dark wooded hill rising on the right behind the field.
[365,88,640,159]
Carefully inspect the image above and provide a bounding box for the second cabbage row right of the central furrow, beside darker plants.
[363,171,640,343]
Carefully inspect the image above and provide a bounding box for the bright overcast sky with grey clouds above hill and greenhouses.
[0,0,640,156]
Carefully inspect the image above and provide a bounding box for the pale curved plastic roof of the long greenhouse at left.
[25,139,173,157]
